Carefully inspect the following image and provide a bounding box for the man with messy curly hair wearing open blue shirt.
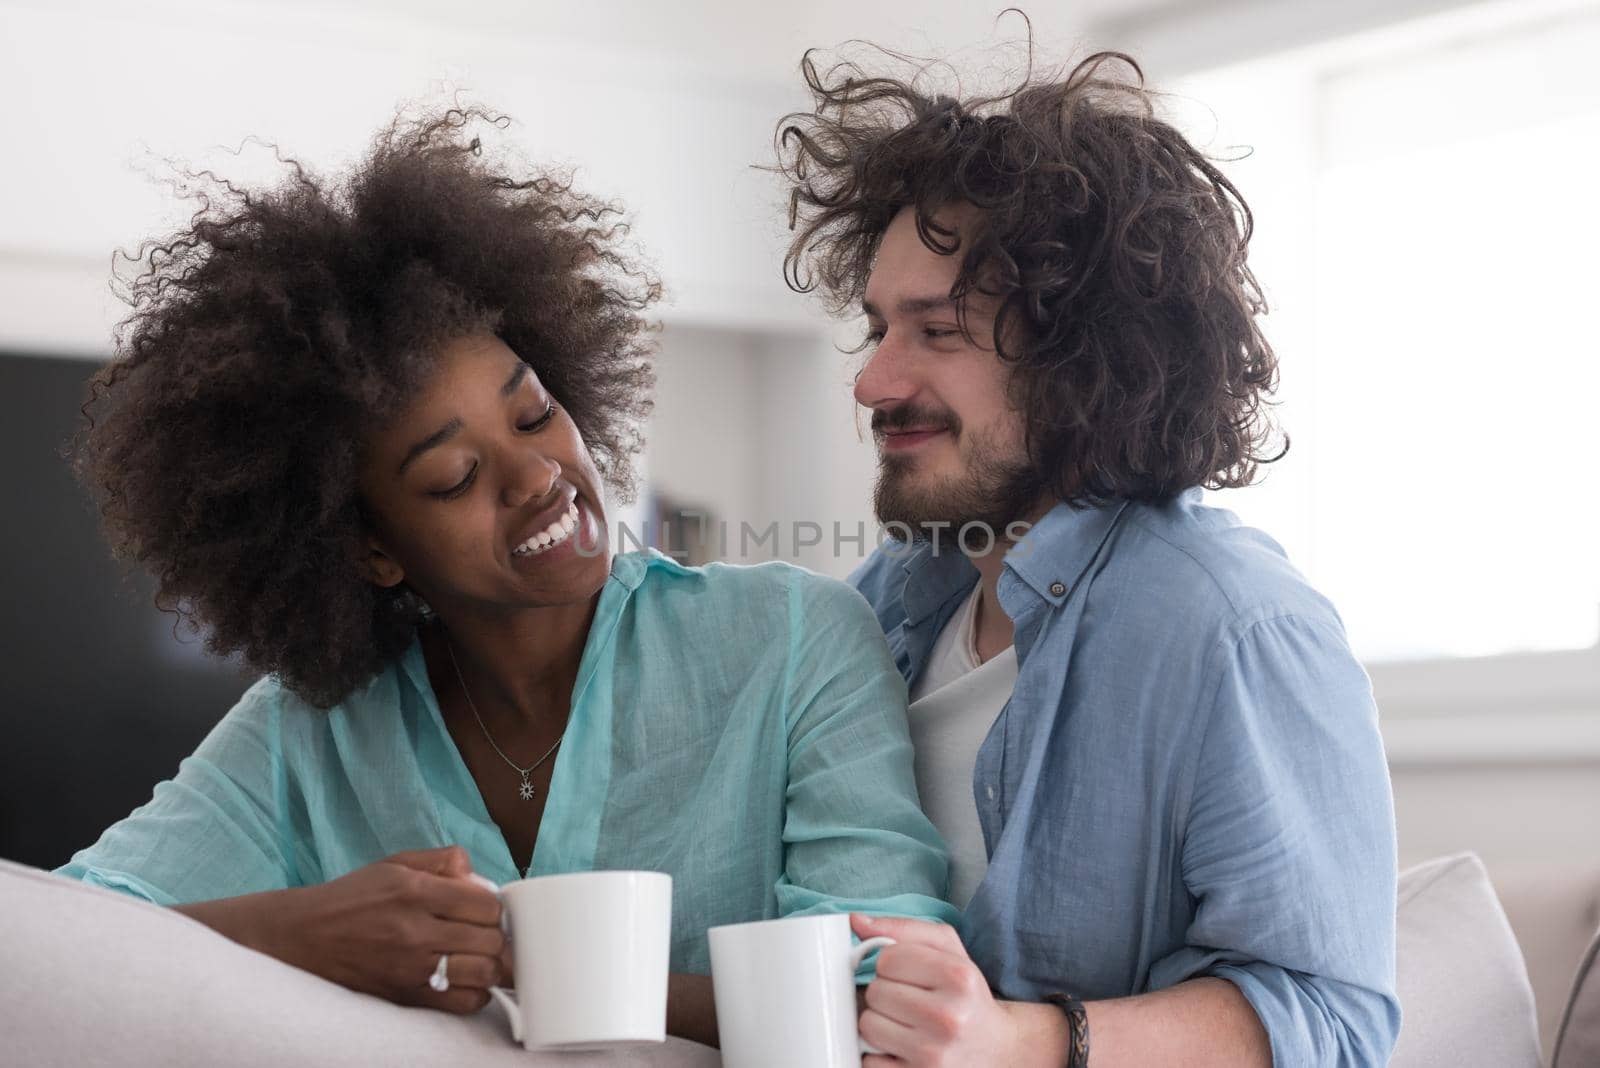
[779,45,1400,1068]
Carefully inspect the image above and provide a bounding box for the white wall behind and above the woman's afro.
[0,0,818,353]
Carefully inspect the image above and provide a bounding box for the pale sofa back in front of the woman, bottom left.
[0,860,718,1068]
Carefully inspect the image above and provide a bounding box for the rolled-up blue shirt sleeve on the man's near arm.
[1150,616,1400,1065]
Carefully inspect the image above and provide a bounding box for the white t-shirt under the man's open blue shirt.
[910,585,1016,908]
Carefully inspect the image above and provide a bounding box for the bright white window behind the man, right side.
[1179,2,1600,678]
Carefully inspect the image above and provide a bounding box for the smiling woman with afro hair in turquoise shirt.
[61,109,955,1041]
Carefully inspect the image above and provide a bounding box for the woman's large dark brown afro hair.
[75,107,659,707]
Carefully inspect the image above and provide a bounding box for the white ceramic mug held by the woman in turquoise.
[483,871,672,1050]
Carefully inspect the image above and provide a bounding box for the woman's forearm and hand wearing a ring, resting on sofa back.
[179,846,510,1014]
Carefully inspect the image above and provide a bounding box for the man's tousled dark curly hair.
[778,45,1286,505]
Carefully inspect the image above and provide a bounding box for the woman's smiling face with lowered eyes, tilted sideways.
[360,334,610,616]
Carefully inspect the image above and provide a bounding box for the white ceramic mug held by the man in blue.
[707,913,894,1068]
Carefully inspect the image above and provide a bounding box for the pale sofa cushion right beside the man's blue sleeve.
[1389,854,1539,1068]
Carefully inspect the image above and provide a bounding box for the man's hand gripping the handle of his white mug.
[850,915,1067,1068]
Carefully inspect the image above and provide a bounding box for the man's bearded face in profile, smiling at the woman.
[856,208,1042,545]
